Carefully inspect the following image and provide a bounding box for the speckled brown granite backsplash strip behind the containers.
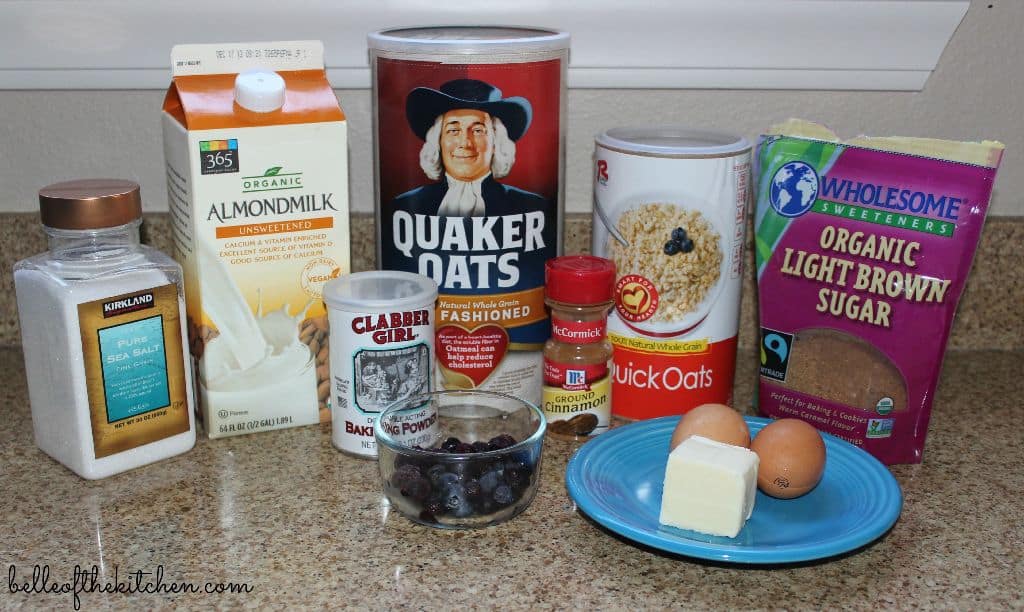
[0,213,1024,350]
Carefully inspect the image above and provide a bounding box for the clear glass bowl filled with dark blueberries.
[374,391,547,529]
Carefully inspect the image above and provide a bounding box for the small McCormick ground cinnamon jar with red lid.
[541,255,615,440]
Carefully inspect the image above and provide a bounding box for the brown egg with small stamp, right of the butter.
[751,419,825,499]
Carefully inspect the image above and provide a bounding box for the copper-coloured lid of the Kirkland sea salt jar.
[39,178,142,229]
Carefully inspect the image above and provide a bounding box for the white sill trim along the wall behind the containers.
[0,0,970,91]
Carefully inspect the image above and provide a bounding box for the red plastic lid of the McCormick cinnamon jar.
[544,255,615,305]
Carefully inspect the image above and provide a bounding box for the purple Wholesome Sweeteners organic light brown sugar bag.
[755,120,1004,464]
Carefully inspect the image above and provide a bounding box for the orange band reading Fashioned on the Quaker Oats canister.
[437,287,548,331]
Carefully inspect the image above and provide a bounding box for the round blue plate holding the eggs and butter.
[565,417,903,563]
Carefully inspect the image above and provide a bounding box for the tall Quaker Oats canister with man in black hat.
[370,27,569,403]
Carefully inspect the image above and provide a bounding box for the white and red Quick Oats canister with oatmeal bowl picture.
[592,126,751,420]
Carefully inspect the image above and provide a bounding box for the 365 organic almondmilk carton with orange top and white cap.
[163,41,349,438]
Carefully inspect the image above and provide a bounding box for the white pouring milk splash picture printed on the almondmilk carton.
[199,241,318,431]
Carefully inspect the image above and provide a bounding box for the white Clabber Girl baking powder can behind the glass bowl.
[324,270,437,457]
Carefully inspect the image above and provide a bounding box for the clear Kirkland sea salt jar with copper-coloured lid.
[14,179,196,479]
